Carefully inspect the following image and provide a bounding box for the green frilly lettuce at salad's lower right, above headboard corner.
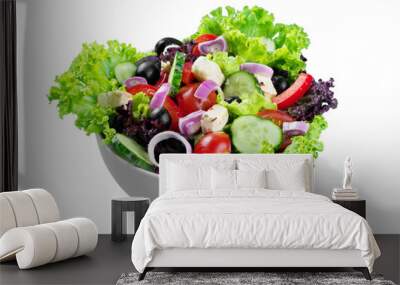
[284,115,328,158]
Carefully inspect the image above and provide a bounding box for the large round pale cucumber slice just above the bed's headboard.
[231,115,283,153]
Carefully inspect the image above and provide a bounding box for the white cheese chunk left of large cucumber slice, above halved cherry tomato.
[201,105,229,133]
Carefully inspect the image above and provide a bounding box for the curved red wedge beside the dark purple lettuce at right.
[272,73,314,110]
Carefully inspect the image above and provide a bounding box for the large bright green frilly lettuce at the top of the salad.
[193,6,310,80]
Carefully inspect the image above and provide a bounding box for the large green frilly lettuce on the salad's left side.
[48,41,151,143]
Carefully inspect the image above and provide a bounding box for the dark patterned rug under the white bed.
[117,272,395,285]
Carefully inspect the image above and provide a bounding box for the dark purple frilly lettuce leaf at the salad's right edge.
[288,78,338,121]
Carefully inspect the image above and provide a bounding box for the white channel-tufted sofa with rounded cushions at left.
[0,189,98,269]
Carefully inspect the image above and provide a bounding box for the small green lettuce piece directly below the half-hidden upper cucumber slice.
[217,92,276,117]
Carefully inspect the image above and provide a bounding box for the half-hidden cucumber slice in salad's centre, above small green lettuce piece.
[224,71,263,98]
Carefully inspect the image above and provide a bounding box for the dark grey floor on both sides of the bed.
[0,235,400,285]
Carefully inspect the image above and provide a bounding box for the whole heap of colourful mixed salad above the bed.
[49,6,337,172]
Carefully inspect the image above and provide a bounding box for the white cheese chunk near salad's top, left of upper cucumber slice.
[192,56,225,86]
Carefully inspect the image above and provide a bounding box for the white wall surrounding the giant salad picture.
[17,0,400,233]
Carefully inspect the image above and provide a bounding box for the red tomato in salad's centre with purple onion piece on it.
[176,83,217,116]
